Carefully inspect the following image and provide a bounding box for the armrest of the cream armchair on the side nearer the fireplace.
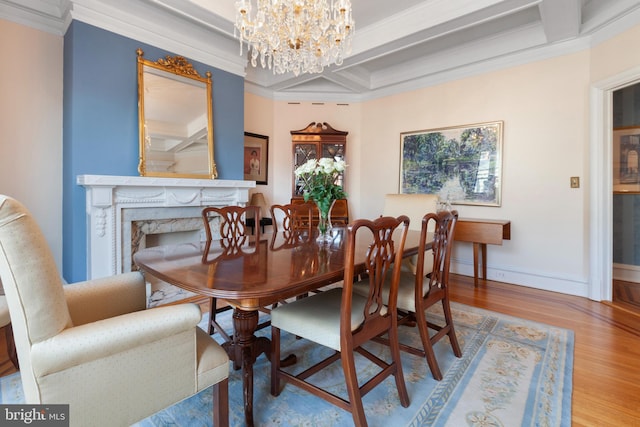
[63,271,147,326]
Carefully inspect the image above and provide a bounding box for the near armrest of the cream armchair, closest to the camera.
[31,304,202,376]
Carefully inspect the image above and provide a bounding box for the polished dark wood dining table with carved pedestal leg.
[134,227,420,426]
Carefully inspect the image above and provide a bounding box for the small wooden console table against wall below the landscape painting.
[454,218,511,286]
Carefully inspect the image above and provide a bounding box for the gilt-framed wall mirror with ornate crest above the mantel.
[136,49,218,179]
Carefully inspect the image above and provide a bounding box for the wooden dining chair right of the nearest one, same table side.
[355,211,462,381]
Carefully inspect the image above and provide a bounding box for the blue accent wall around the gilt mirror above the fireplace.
[62,21,244,282]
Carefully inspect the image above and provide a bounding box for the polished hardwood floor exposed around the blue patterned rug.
[0,275,640,427]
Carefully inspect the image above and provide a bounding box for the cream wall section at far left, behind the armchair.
[0,20,63,269]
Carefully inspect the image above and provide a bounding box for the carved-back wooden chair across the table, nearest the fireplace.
[202,206,260,342]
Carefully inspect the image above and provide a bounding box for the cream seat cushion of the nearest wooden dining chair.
[271,288,386,351]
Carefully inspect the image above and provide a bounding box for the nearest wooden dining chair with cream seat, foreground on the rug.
[271,216,409,426]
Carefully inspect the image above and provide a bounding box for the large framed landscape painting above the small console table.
[399,121,503,206]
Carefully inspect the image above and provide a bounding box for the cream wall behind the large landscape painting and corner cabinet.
[245,51,590,296]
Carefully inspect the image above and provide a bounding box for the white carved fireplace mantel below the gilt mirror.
[77,175,256,279]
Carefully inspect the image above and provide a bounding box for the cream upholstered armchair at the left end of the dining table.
[0,195,229,426]
